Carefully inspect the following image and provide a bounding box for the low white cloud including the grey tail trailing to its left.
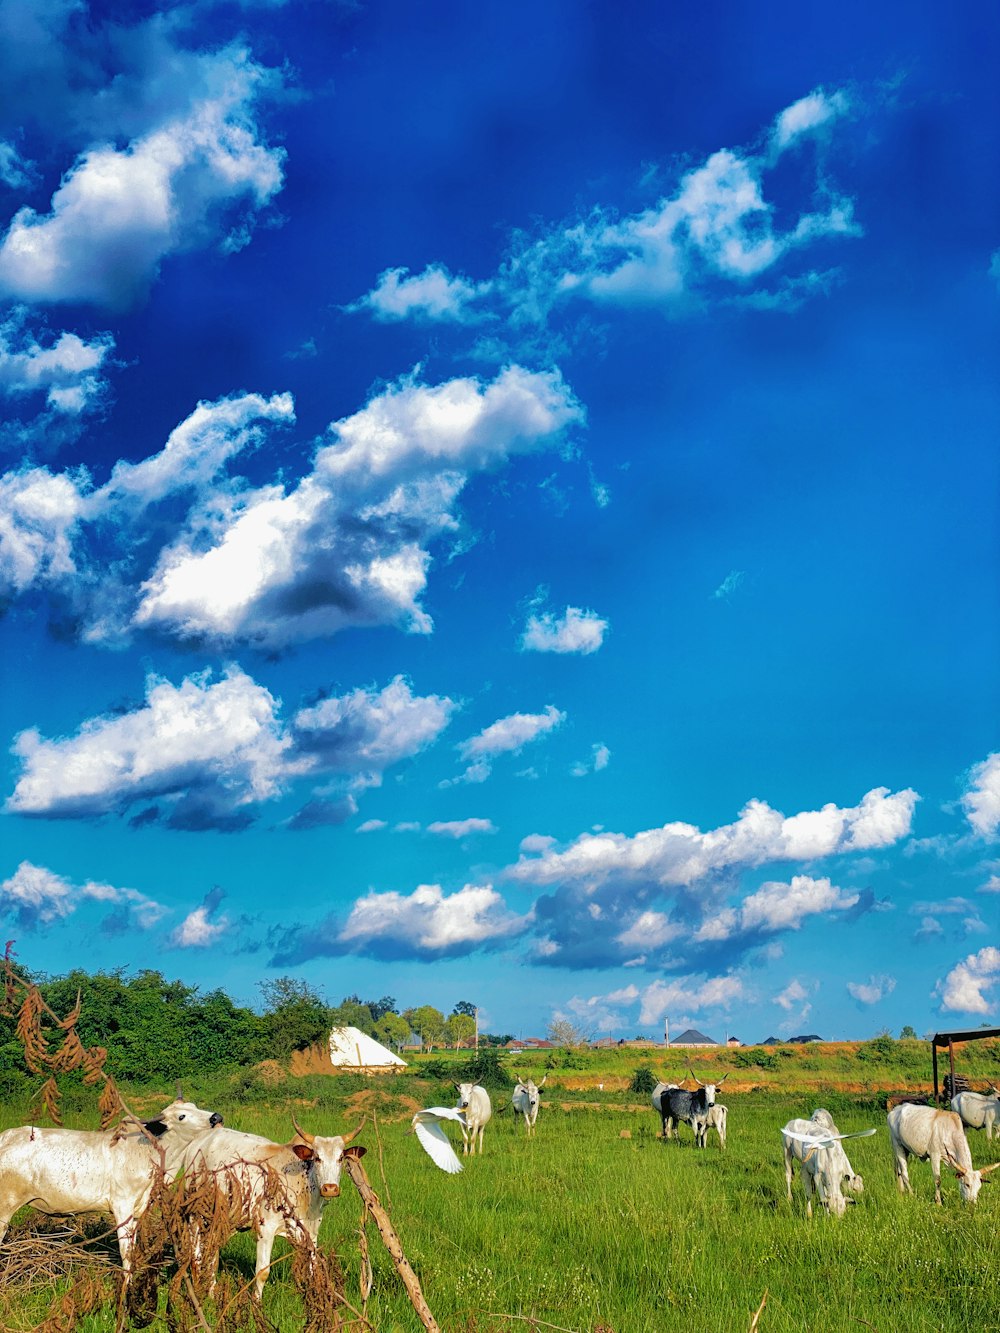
[272,884,529,966]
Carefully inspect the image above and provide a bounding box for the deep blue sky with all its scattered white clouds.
[0,0,1000,1040]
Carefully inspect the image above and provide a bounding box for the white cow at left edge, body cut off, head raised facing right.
[0,1100,223,1273]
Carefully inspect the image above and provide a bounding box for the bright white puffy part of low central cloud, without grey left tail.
[339,884,529,954]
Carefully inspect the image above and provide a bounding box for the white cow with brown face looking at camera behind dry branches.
[183,1120,365,1300]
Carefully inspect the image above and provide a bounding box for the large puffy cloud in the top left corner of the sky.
[0,48,284,308]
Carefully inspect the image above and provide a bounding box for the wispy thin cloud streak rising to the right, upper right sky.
[353,89,860,335]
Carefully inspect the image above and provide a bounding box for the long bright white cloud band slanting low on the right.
[505,786,917,888]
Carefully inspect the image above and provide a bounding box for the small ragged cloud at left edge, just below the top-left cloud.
[0,309,115,416]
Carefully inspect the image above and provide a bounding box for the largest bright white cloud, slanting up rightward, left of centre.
[135,367,581,647]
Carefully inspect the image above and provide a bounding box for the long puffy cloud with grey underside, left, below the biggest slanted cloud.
[5,667,453,830]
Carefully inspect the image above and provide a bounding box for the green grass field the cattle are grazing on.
[0,1058,1000,1333]
